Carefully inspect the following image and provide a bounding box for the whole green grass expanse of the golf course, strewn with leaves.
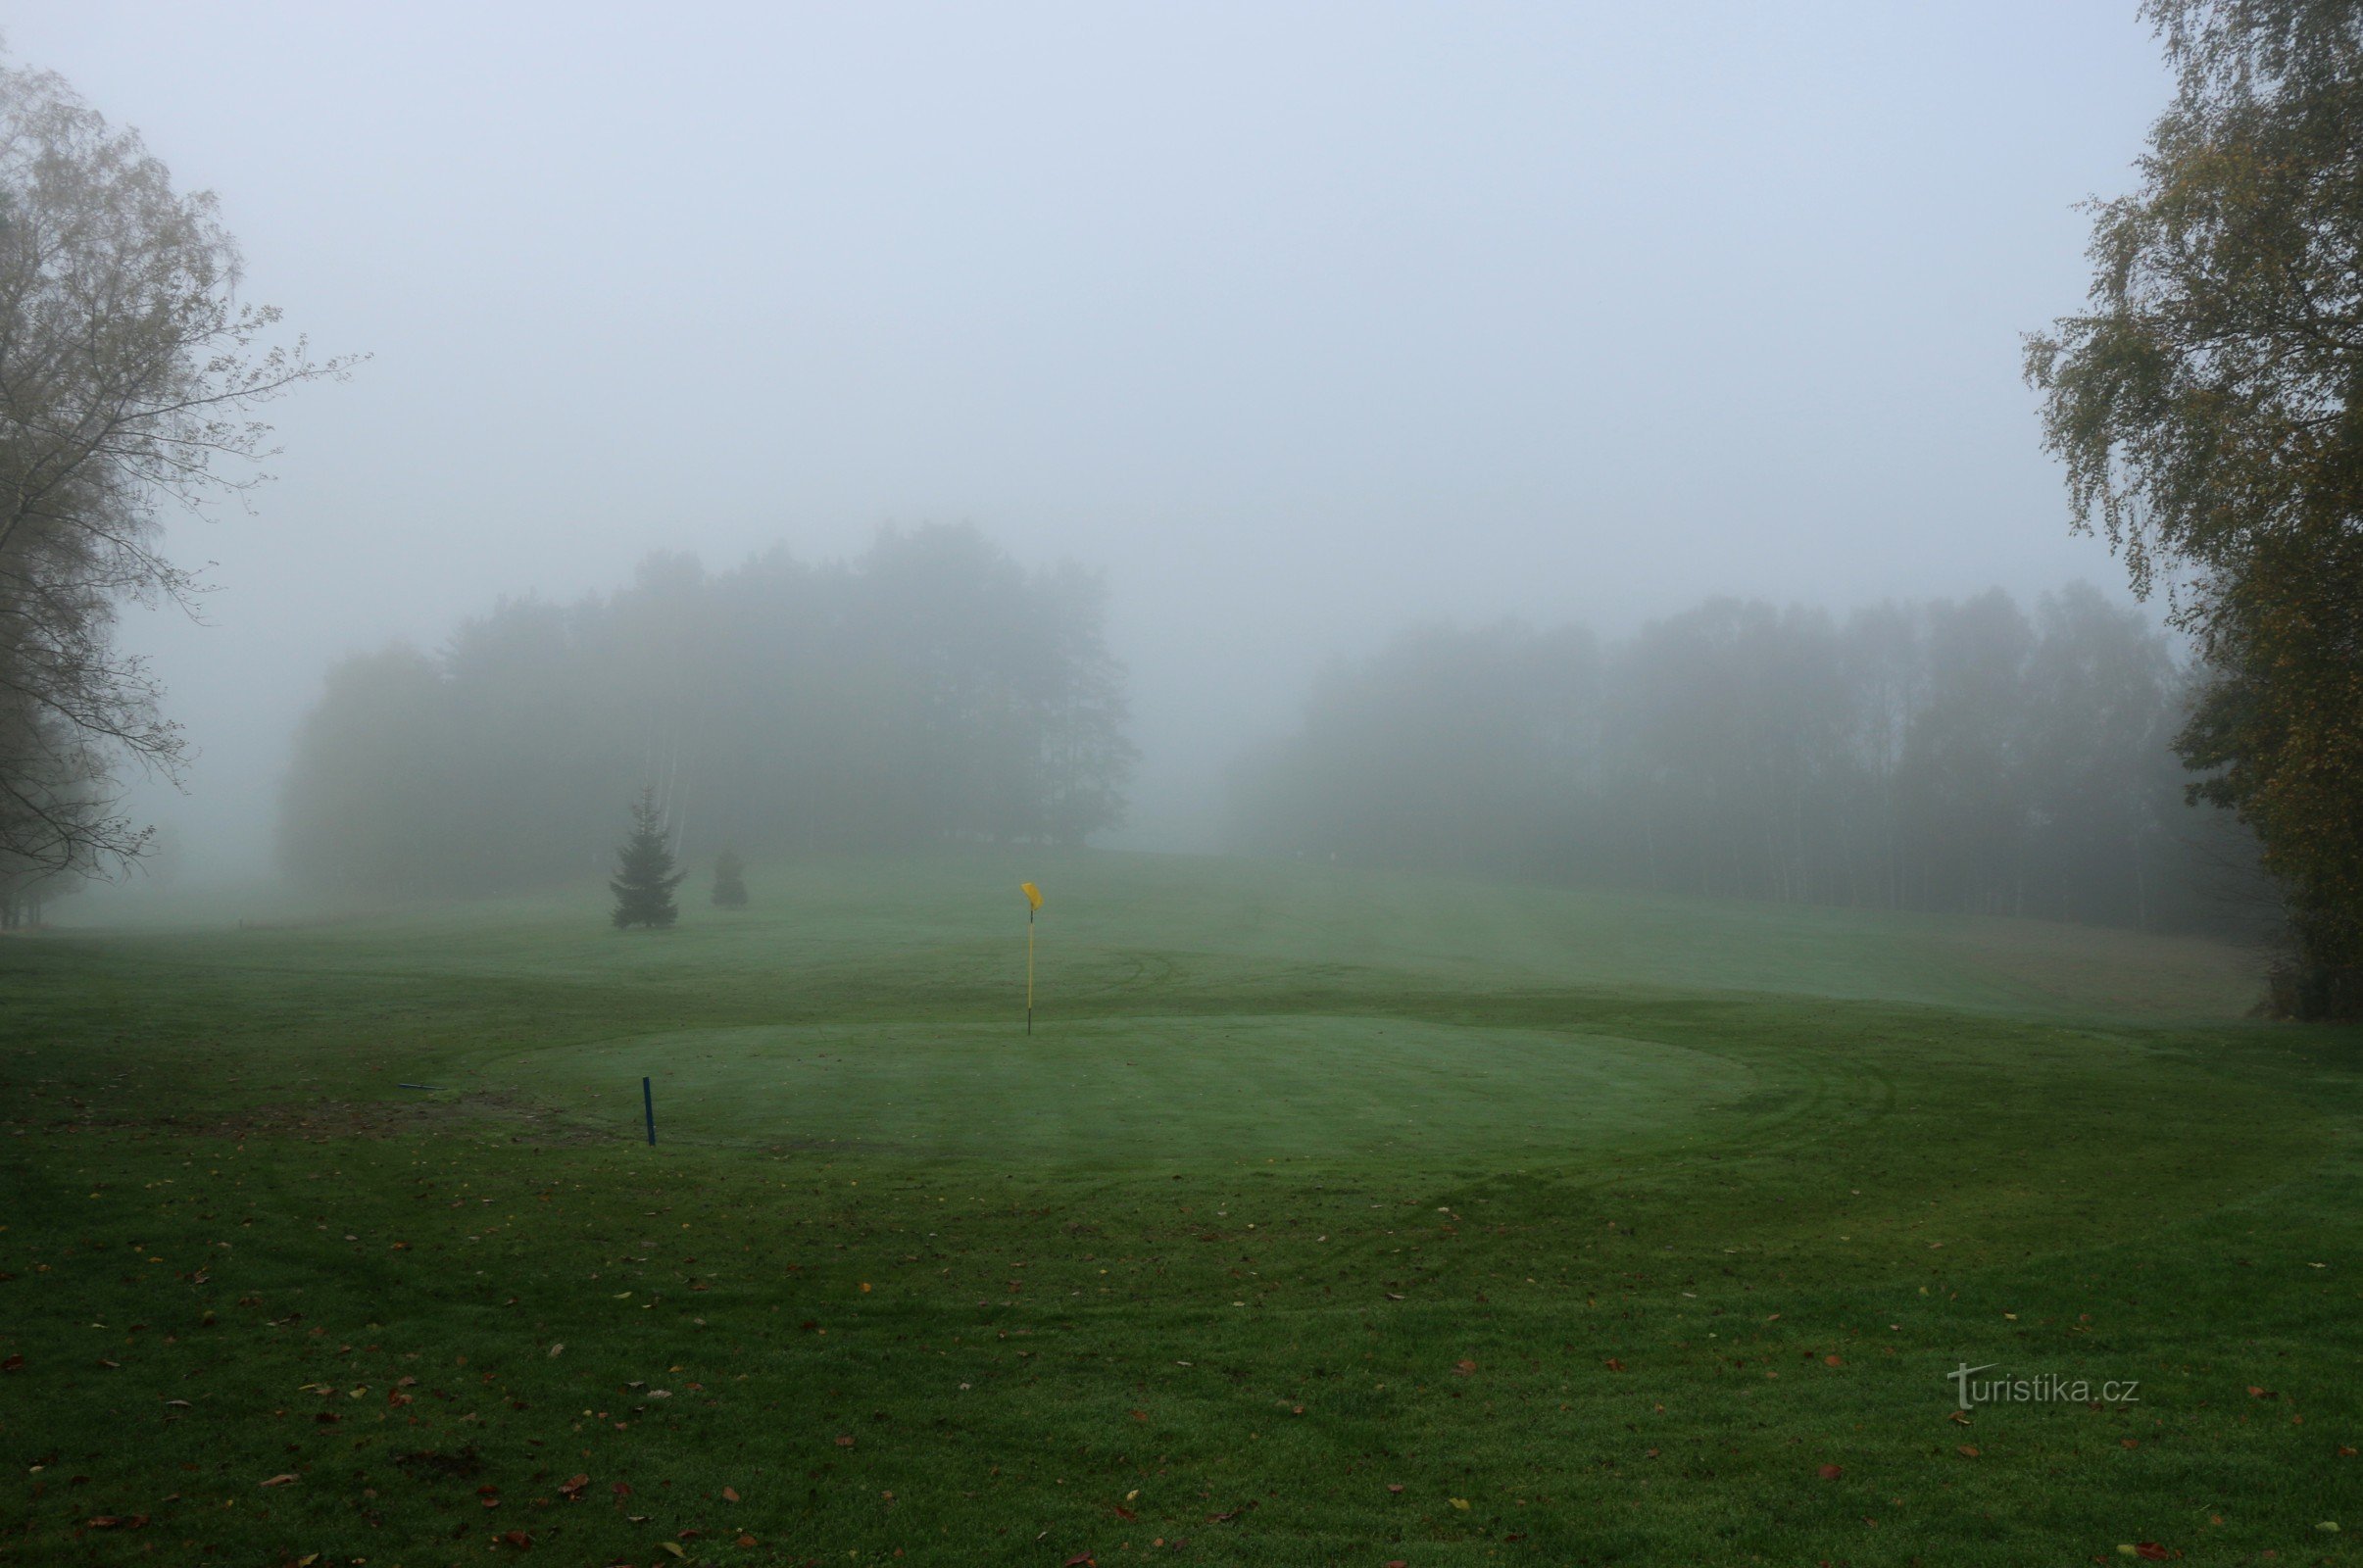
[0,855,2363,1568]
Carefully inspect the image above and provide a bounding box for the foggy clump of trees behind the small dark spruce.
[278,526,1134,895]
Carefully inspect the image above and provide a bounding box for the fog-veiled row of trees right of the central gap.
[1231,586,2273,930]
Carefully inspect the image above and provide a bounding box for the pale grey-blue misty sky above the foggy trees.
[7,0,2167,869]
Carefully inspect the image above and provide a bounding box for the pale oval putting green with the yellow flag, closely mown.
[511,1013,1751,1171]
